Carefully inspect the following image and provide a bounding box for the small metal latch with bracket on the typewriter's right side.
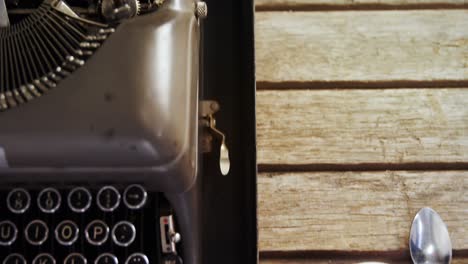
[200,100,231,175]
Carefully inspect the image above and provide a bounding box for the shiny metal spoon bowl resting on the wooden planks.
[409,207,452,264]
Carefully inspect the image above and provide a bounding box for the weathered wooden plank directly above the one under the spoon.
[257,88,468,165]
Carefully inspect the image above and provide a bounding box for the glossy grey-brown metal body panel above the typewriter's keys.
[0,4,199,192]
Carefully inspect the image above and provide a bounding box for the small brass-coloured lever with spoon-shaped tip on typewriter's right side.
[200,100,231,176]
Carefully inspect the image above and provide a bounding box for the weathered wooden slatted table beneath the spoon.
[256,0,468,264]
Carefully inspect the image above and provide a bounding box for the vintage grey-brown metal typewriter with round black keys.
[0,0,256,264]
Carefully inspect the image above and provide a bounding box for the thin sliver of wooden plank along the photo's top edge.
[255,0,468,9]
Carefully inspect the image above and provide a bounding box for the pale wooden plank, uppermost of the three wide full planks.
[256,10,468,82]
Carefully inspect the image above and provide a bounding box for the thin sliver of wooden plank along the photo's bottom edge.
[260,257,468,264]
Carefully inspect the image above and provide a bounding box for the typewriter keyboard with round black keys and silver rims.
[0,184,180,264]
